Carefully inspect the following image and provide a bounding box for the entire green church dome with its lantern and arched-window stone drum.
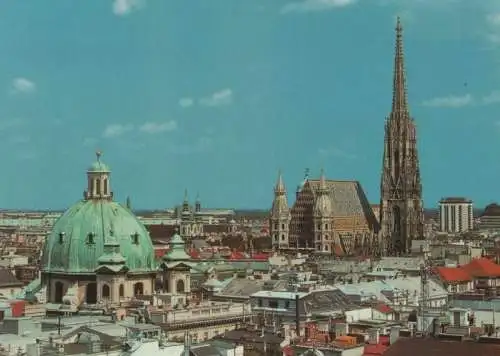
[41,153,157,306]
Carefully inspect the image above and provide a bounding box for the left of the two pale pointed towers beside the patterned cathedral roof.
[269,172,291,248]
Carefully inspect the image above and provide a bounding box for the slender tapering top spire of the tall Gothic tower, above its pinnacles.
[392,16,408,113]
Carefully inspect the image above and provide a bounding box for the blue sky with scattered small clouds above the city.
[0,0,500,209]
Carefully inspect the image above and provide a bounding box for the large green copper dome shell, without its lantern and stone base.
[42,199,156,274]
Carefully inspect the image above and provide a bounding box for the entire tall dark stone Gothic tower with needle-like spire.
[379,17,424,256]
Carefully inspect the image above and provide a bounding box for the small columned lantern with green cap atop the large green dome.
[84,151,113,200]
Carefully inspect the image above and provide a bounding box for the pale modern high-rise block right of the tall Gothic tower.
[439,197,474,232]
